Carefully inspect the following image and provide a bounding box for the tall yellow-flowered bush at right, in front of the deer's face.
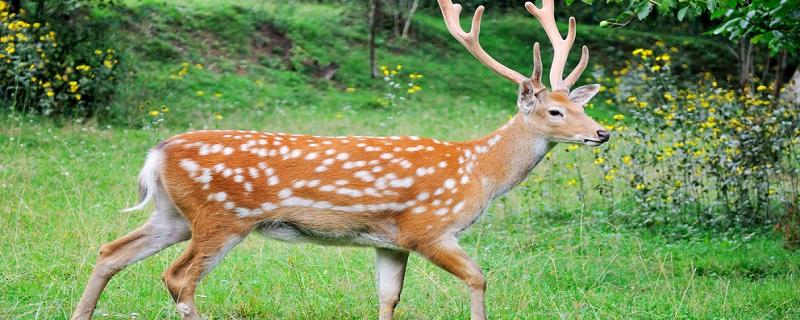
[595,42,800,235]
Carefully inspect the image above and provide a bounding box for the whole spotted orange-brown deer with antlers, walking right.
[72,0,611,319]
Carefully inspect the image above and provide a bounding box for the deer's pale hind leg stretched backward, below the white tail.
[72,204,191,319]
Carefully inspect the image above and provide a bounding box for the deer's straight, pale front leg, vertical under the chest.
[375,248,408,320]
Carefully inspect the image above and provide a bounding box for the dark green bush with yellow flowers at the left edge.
[0,1,119,118]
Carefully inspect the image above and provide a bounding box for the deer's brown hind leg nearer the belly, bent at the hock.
[161,225,247,320]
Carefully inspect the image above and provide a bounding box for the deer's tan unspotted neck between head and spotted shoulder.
[464,114,556,199]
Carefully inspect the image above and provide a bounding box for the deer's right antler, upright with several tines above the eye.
[525,0,589,91]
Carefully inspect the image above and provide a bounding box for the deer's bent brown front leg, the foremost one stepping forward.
[416,239,486,320]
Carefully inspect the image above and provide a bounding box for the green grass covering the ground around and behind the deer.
[0,0,800,319]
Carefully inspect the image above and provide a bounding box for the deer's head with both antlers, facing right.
[439,0,611,146]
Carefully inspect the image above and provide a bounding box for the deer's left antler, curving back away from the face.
[439,0,526,84]
